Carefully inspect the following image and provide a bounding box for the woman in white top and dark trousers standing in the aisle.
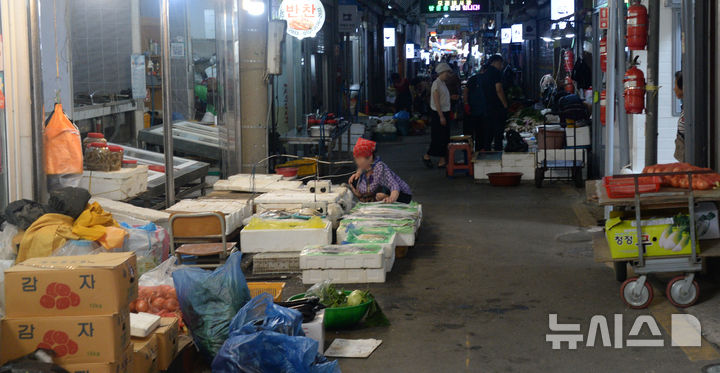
[423,62,452,168]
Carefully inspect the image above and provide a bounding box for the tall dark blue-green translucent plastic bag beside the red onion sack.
[172,252,250,361]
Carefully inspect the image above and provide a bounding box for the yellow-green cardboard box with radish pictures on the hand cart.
[605,213,700,259]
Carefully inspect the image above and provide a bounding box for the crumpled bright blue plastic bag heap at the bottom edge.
[212,293,340,373]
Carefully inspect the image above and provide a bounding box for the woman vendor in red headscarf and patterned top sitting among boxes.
[349,138,412,203]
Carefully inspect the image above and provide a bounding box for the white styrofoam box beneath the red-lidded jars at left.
[80,165,148,201]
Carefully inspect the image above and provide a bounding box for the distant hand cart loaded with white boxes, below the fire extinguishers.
[535,123,587,188]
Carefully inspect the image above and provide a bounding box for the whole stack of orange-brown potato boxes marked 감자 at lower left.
[0,253,138,373]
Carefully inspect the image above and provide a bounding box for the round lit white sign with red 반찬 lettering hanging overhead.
[278,0,325,39]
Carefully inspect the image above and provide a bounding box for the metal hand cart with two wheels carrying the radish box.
[588,171,720,309]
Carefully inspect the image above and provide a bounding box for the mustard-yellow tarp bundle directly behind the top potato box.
[16,214,79,263]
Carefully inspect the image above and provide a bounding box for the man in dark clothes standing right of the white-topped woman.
[480,54,508,151]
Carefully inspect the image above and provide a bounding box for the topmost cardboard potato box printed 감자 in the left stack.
[5,253,138,318]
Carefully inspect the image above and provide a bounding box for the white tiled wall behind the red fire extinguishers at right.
[630,0,678,171]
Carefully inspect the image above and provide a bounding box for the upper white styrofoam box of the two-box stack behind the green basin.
[300,245,394,269]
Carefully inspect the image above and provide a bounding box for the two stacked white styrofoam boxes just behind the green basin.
[300,244,388,284]
